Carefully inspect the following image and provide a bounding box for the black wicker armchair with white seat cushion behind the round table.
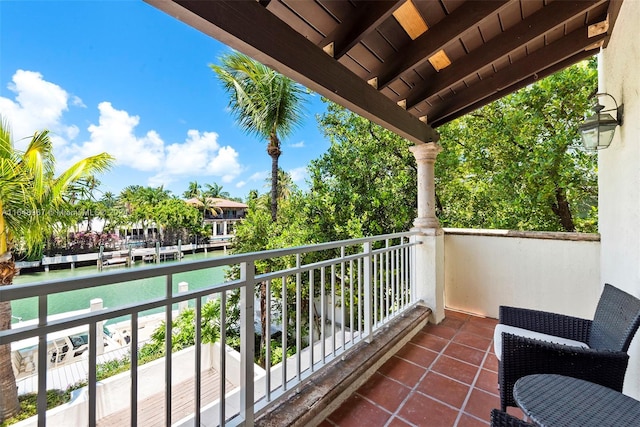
[498,284,640,411]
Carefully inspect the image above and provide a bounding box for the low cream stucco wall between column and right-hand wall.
[444,229,602,318]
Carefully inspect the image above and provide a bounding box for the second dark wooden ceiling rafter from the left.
[370,0,509,89]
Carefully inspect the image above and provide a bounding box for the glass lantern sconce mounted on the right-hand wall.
[578,93,624,151]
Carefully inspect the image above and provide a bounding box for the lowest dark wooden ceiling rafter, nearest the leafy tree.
[428,27,607,125]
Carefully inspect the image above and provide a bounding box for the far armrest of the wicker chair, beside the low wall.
[500,305,592,343]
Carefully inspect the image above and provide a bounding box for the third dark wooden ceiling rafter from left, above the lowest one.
[404,0,602,109]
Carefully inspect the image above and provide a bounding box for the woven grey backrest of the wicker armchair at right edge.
[587,283,640,352]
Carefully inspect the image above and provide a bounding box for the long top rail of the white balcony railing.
[0,231,419,301]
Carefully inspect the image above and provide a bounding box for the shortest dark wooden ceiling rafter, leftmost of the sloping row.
[321,0,405,59]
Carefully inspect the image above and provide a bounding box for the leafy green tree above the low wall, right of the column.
[436,61,597,232]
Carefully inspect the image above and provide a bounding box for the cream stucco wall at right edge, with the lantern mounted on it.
[598,0,640,399]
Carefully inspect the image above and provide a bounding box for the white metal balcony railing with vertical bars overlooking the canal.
[0,232,416,426]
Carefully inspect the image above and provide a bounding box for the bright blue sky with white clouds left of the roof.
[0,0,329,201]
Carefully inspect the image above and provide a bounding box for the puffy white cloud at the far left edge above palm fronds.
[0,70,82,149]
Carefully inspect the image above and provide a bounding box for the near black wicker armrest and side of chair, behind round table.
[498,333,629,410]
